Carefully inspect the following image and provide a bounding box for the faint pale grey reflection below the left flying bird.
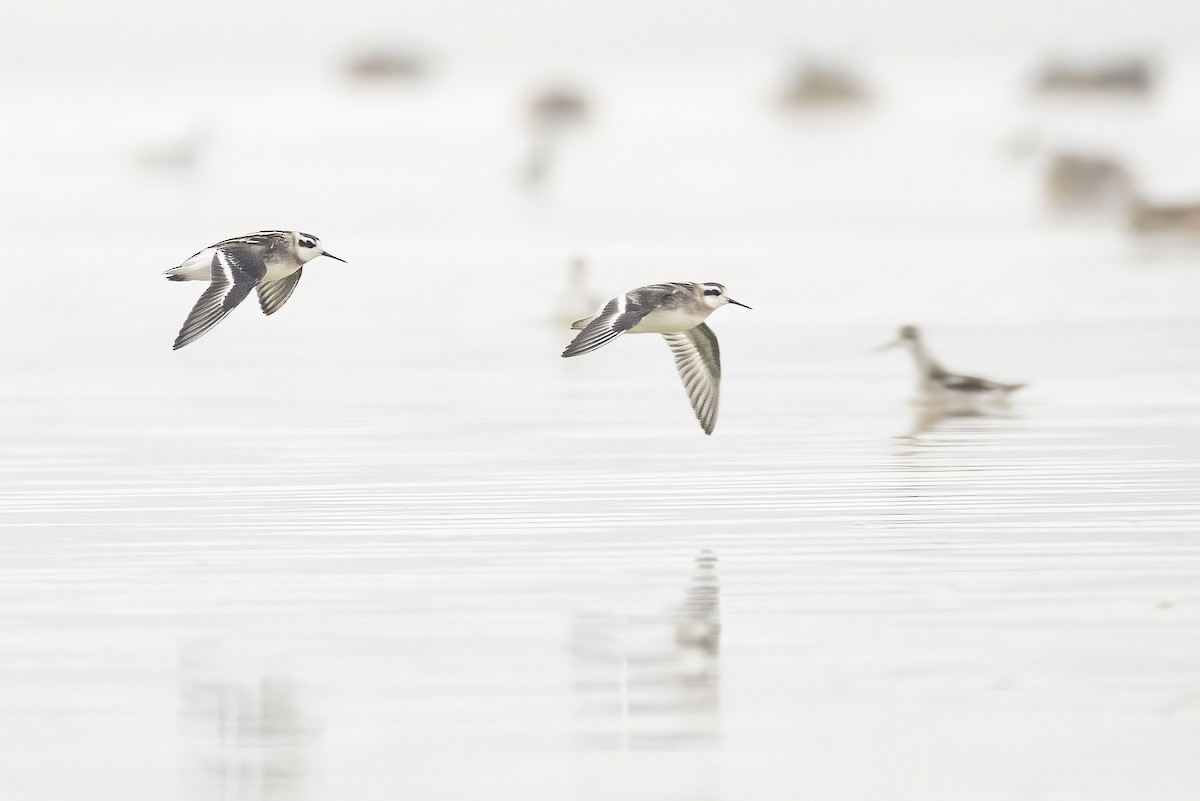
[180,643,318,801]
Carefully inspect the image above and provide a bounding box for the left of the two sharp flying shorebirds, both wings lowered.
[166,231,346,350]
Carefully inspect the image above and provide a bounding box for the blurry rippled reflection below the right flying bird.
[572,550,721,801]
